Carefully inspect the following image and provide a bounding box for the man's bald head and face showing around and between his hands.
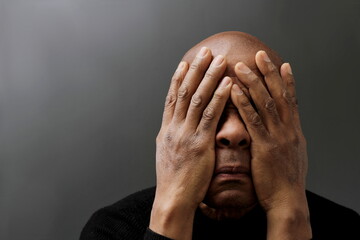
[178,31,283,214]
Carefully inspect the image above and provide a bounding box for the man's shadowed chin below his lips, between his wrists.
[204,182,258,209]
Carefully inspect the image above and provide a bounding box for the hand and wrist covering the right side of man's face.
[231,51,311,239]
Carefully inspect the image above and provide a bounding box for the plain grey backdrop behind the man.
[0,0,360,240]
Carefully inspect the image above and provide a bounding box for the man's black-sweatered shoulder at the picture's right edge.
[306,191,360,239]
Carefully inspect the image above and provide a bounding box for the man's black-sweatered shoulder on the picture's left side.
[80,187,155,240]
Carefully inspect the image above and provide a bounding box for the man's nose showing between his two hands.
[216,114,250,148]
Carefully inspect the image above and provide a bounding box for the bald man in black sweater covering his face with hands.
[81,32,360,239]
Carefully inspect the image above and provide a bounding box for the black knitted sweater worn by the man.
[80,187,360,240]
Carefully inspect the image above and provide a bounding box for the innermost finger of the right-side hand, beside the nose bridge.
[231,84,268,139]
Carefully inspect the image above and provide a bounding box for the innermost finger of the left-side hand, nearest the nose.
[197,77,232,133]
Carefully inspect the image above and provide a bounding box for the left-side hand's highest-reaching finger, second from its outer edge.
[174,47,211,122]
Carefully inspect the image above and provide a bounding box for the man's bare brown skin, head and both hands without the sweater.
[150,32,311,239]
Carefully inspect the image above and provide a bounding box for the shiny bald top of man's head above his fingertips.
[183,31,283,77]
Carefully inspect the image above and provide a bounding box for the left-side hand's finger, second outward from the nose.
[185,55,226,129]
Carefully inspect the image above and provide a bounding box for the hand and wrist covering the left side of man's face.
[150,48,232,239]
